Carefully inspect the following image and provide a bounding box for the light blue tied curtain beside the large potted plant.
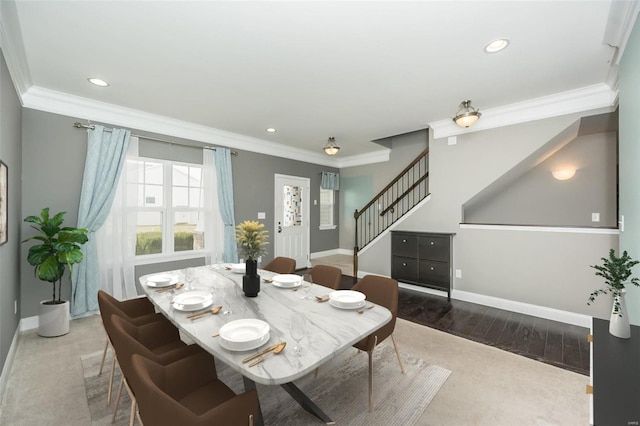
[71,125,131,316]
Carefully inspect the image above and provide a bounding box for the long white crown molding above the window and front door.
[22,86,389,168]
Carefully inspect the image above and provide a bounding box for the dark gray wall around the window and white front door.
[17,109,339,318]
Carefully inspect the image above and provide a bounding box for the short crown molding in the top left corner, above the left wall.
[0,1,32,98]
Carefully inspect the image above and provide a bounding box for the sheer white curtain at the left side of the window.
[95,137,138,300]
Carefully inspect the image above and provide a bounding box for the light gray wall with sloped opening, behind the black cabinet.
[352,111,618,317]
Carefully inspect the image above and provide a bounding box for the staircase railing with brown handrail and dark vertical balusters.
[353,148,429,277]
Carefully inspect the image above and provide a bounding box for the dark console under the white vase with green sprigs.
[591,318,640,426]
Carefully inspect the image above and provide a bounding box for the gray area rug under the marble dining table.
[82,343,451,426]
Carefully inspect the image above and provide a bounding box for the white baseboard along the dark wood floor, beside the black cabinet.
[358,271,591,328]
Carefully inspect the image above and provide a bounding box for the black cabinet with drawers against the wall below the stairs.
[391,231,455,300]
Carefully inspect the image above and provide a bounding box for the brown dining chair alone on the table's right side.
[352,275,404,412]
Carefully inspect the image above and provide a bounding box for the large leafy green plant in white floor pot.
[22,207,89,337]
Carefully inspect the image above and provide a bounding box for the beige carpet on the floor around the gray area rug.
[0,316,589,426]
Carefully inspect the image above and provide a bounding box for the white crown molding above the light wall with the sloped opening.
[429,83,618,139]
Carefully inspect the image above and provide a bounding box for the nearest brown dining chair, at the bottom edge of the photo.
[131,353,260,426]
